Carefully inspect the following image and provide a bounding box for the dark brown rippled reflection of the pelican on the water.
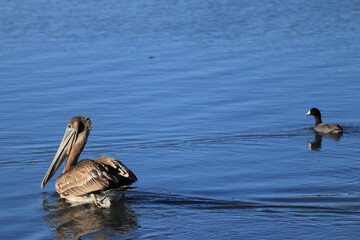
[42,194,139,239]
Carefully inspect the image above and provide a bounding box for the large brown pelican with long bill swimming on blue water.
[41,116,137,207]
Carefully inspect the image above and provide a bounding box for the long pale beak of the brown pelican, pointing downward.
[41,128,76,188]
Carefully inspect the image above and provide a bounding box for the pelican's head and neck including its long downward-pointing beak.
[41,116,91,188]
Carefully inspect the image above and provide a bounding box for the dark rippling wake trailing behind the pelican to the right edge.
[127,191,360,213]
